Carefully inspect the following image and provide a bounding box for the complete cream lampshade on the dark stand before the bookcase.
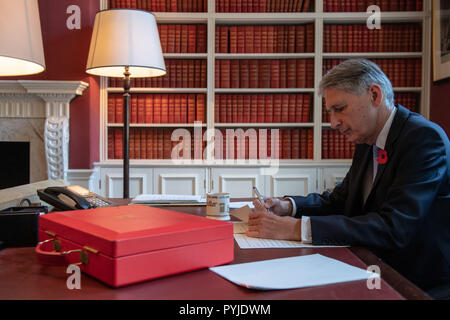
[86,9,166,77]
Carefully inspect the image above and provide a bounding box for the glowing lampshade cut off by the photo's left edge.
[0,0,45,76]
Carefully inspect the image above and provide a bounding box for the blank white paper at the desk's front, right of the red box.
[209,254,379,290]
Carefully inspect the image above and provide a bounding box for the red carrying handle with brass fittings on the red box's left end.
[35,238,89,266]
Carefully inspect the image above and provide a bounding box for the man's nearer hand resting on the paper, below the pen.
[247,200,301,240]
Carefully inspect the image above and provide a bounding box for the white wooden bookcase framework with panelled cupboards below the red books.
[93,0,431,197]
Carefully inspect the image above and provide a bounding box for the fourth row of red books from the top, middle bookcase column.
[214,94,312,123]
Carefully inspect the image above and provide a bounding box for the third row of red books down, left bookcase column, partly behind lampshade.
[108,59,207,88]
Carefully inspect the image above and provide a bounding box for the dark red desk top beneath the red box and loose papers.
[0,202,429,300]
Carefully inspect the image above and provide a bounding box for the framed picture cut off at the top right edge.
[433,0,450,81]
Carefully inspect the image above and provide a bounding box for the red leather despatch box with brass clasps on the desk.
[36,205,234,287]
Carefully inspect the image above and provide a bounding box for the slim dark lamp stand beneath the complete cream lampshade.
[123,67,131,199]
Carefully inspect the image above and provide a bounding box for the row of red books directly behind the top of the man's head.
[323,58,422,87]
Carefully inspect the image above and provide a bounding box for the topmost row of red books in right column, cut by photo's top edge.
[323,0,423,12]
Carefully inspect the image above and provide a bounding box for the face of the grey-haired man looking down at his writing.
[325,88,376,144]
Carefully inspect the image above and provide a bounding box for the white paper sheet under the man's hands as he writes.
[234,232,346,249]
